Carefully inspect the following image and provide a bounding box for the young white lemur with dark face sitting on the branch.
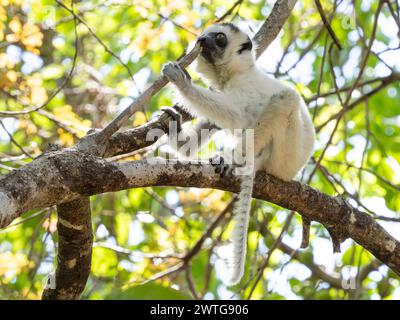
[162,23,315,284]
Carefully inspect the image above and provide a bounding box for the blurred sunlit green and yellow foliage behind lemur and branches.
[0,0,400,299]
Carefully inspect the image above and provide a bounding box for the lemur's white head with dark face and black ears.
[198,23,252,65]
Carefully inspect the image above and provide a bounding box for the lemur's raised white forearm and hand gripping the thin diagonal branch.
[162,62,240,127]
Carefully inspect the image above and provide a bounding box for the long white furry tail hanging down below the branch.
[227,173,254,285]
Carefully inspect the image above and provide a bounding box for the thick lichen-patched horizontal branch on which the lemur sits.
[0,149,400,275]
